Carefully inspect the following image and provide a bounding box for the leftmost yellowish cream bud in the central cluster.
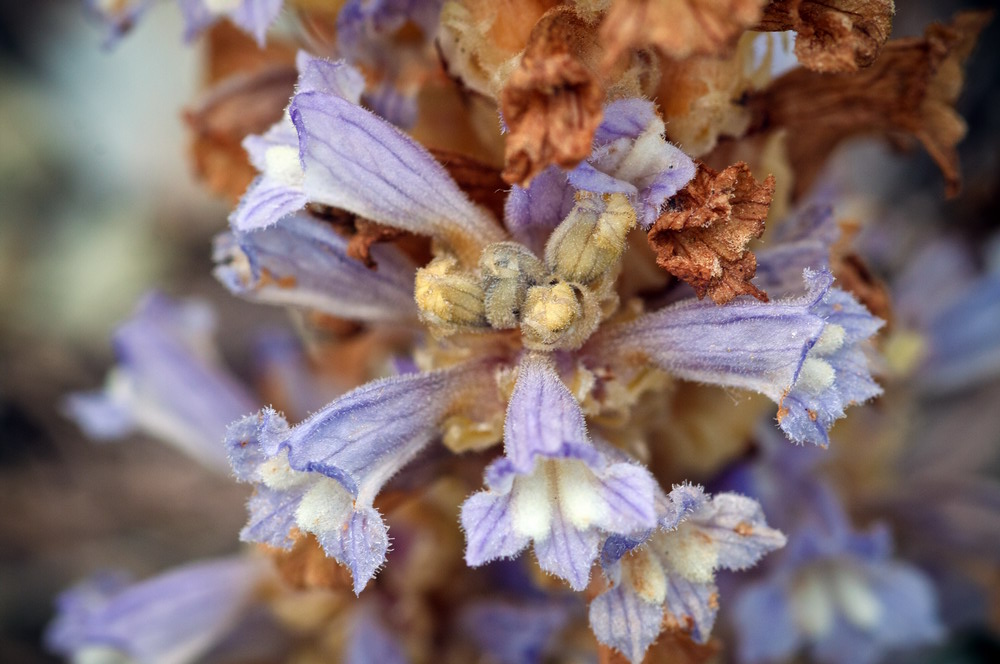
[414,257,487,329]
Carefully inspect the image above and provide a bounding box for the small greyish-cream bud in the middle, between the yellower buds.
[479,242,545,330]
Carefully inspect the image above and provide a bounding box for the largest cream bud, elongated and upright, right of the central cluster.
[545,194,636,284]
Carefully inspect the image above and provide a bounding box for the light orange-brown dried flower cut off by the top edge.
[600,0,767,69]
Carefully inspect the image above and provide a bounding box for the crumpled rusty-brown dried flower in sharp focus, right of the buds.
[649,162,774,304]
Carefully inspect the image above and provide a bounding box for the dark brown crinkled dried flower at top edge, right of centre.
[756,0,895,73]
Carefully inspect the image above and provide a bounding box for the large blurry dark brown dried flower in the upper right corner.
[748,12,991,196]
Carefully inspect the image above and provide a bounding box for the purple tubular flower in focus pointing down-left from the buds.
[226,363,495,593]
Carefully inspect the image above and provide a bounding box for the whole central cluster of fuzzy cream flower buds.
[415,194,636,350]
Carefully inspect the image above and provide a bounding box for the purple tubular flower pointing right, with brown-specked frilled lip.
[585,270,882,446]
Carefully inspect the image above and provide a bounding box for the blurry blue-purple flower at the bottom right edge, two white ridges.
[732,501,942,664]
